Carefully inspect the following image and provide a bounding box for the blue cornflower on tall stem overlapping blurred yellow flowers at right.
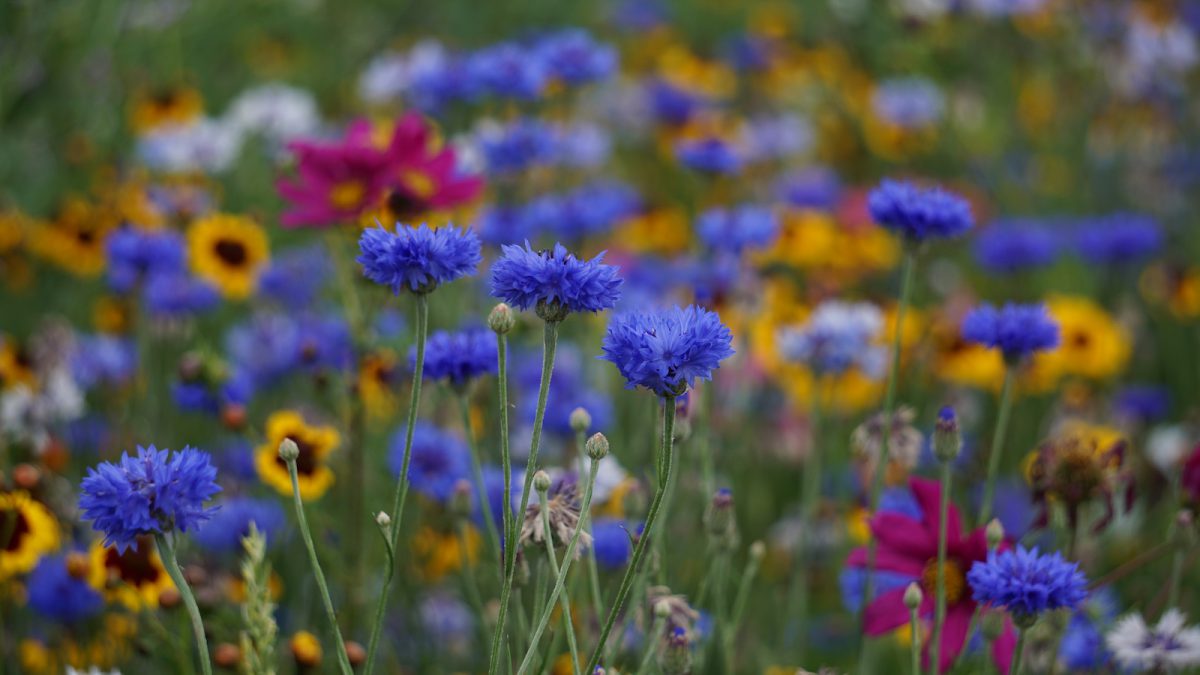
[962,303,1058,363]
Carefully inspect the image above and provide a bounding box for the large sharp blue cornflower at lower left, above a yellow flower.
[79,446,221,552]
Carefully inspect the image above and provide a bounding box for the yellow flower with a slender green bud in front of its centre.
[254,411,342,501]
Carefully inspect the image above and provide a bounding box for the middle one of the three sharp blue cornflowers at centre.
[492,241,620,321]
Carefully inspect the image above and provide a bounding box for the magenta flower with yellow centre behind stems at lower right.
[846,478,1016,673]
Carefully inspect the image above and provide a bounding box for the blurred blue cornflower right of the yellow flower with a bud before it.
[388,422,470,503]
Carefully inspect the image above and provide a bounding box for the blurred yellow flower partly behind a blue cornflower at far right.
[1039,295,1132,380]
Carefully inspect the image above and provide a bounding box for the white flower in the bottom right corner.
[1105,608,1200,673]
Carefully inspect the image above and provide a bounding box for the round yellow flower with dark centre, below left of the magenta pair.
[187,214,270,300]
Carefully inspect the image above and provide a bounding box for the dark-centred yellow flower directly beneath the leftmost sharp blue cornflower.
[88,537,175,611]
